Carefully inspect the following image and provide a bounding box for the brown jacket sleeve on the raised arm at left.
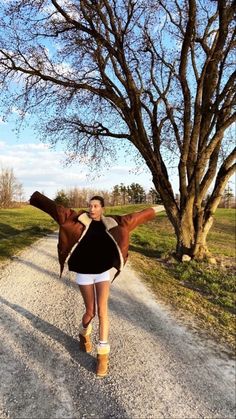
[29,191,74,225]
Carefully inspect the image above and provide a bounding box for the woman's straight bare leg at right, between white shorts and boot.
[95,281,110,342]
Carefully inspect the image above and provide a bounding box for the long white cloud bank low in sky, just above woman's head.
[0,140,153,199]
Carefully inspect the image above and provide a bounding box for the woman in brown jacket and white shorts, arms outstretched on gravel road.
[30,192,164,377]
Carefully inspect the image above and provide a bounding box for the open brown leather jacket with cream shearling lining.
[29,191,156,277]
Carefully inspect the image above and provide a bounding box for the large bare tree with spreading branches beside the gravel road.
[0,0,235,258]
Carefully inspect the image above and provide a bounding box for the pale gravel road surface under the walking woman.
[0,234,235,419]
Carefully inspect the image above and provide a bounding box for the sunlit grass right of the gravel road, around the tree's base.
[130,209,236,349]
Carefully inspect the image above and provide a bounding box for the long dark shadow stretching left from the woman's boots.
[0,297,96,372]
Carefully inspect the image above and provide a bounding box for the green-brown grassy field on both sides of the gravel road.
[0,205,235,348]
